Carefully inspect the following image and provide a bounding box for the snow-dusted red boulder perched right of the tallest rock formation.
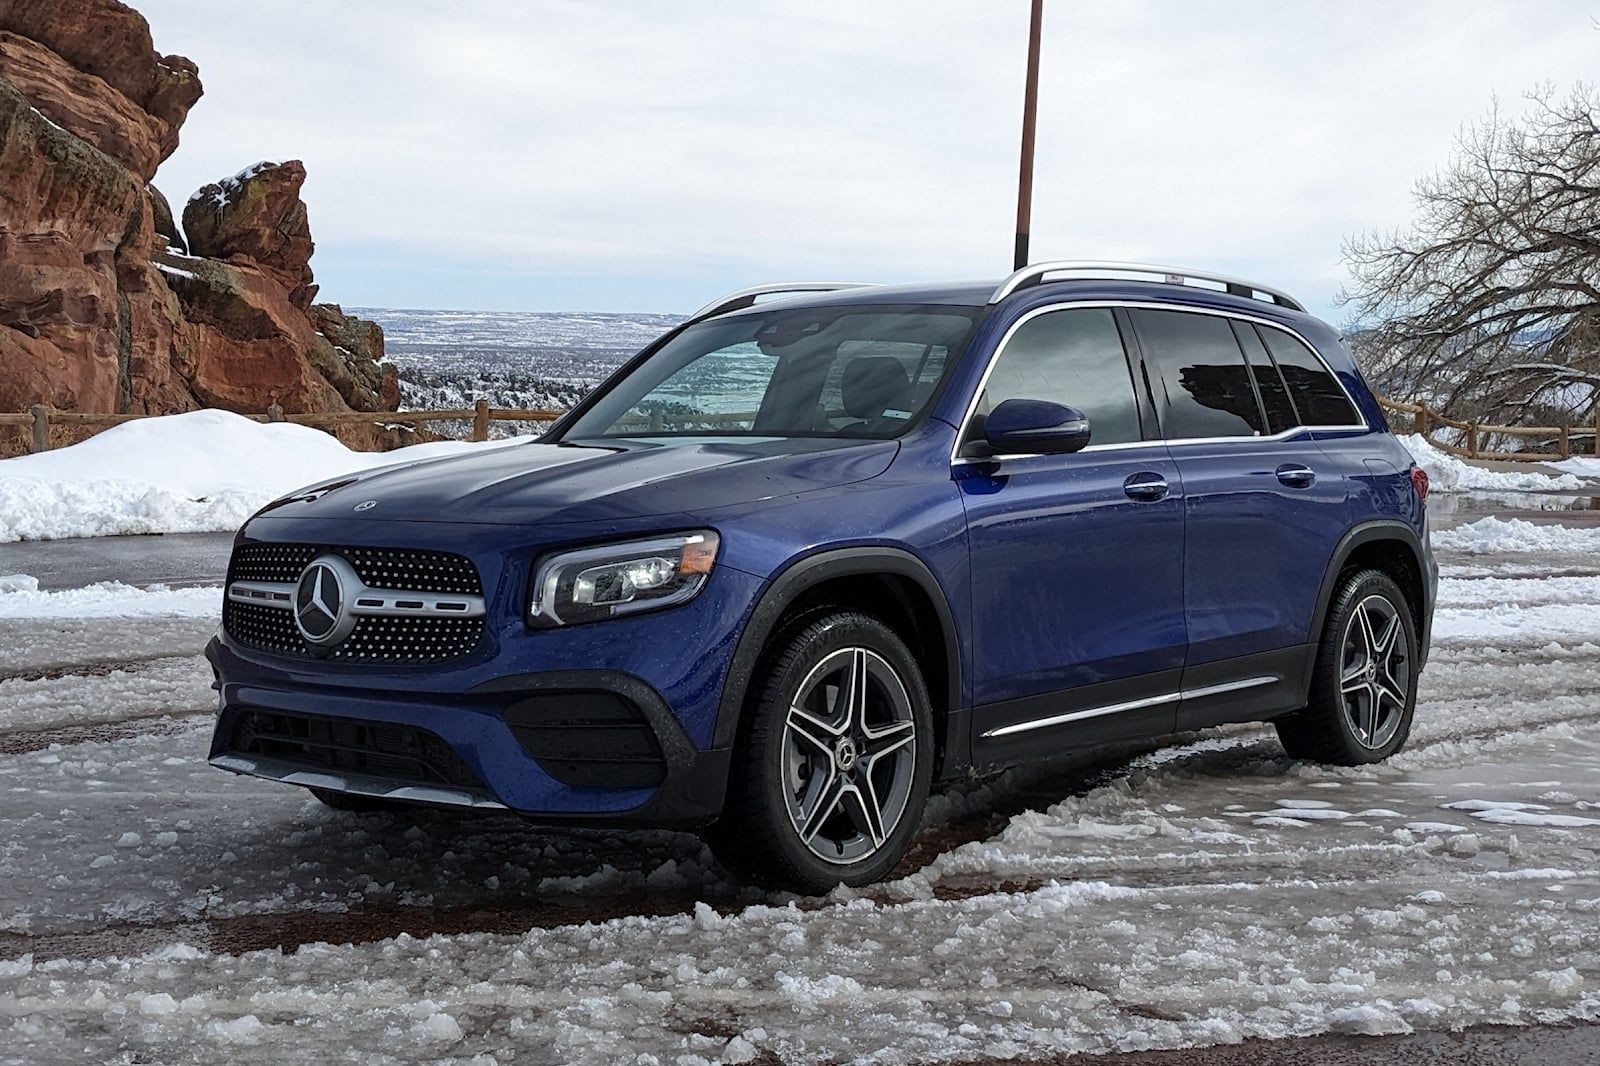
[184,158,317,311]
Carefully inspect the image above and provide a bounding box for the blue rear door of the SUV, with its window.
[1130,309,1346,728]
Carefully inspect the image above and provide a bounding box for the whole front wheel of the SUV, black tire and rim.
[707,611,934,893]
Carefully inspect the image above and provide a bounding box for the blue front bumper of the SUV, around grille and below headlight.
[208,519,762,824]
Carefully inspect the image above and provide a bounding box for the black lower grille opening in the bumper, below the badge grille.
[227,707,486,792]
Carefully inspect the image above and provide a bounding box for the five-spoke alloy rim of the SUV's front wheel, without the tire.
[782,647,917,864]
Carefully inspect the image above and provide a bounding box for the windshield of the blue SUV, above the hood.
[563,304,981,440]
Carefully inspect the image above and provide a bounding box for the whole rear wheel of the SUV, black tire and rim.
[1275,570,1418,767]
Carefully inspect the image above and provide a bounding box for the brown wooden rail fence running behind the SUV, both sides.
[0,390,1600,463]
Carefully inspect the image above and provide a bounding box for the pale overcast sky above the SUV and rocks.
[133,0,1600,320]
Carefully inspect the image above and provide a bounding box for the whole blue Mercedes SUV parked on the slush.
[208,262,1437,890]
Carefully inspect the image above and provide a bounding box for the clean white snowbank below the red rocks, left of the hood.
[0,411,531,543]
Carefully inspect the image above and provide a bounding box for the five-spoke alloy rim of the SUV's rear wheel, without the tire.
[1339,595,1411,751]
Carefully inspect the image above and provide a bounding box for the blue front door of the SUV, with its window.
[955,307,1186,762]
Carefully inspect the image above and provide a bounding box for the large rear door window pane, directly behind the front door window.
[1131,311,1266,440]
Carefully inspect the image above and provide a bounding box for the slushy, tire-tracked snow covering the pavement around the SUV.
[0,522,1600,1064]
